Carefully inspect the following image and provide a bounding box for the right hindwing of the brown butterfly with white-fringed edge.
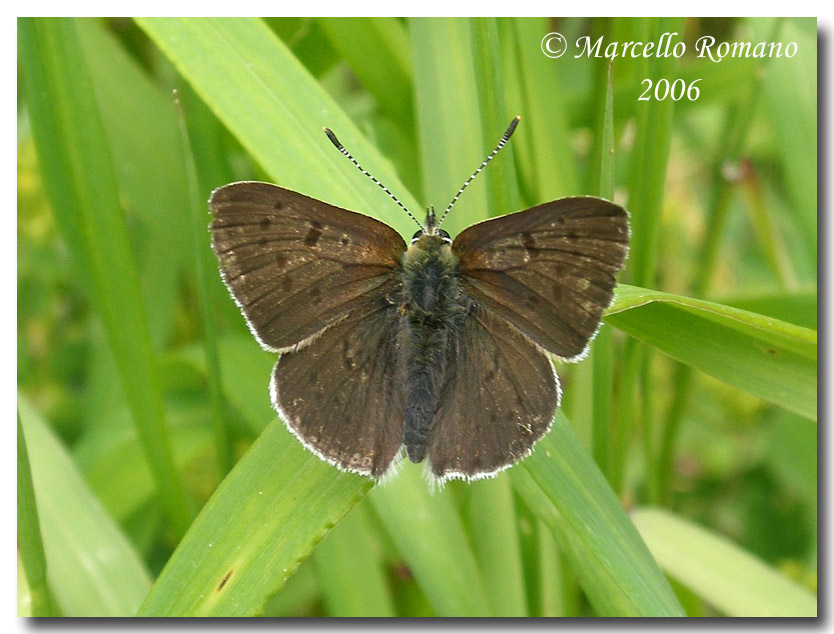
[428,306,560,481]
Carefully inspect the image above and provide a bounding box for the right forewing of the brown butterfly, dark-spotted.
[452,197,629,359]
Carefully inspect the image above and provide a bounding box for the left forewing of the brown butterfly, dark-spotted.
[209,182,405,350]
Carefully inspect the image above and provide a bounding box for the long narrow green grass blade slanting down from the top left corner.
[19,19,191,534]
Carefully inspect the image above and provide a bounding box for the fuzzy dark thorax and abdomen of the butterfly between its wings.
[400,235,472,462]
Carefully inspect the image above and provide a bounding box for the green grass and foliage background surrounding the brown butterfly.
[18,18,817,616]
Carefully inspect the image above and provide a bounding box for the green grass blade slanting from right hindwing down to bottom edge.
[510,413,683,616]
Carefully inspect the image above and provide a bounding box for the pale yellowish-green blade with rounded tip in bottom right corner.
[631,508,817,617]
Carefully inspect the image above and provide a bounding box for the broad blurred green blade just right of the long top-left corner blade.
[76,19,189,350]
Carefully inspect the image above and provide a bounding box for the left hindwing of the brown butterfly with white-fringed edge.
[270,298,405,478]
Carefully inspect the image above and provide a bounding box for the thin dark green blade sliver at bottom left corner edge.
[17,413,56,616]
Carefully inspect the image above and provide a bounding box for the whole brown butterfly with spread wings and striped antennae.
[209,118,629,482]
